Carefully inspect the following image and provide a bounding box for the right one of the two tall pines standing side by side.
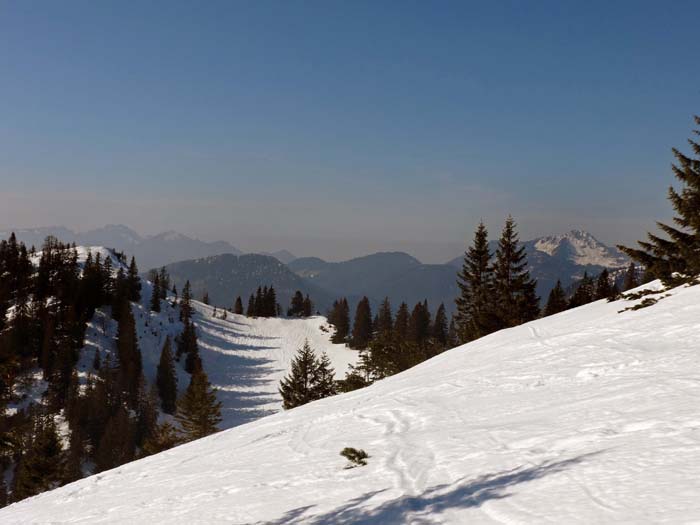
[493,216,540,329]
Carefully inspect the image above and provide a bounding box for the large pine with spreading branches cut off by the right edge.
[618,116,700,283]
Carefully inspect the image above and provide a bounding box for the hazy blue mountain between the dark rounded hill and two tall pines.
[289,252,457,311]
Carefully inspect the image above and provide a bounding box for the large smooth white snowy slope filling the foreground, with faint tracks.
[5,286,700,524]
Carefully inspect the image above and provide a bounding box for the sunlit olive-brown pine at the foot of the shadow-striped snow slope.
[175,367,221,441]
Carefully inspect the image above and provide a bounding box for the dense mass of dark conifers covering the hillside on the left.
[0,234,220,505]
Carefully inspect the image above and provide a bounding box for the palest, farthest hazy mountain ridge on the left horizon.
[0,224,243,268]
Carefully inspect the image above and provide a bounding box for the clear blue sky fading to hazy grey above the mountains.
[0,0,700,262]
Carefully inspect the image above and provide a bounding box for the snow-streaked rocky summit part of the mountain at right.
[534,230,627,268]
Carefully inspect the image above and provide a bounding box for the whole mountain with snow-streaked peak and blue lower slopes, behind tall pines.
[448,230,629,302]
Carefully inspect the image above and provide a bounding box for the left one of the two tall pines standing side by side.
[455,222,496,342]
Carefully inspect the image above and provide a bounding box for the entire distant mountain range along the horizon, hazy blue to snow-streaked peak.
[0,225,629,312]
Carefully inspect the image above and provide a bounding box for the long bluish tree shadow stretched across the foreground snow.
[267,452,600,525]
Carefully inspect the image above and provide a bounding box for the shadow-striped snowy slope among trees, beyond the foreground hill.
[28,246,358,428]
